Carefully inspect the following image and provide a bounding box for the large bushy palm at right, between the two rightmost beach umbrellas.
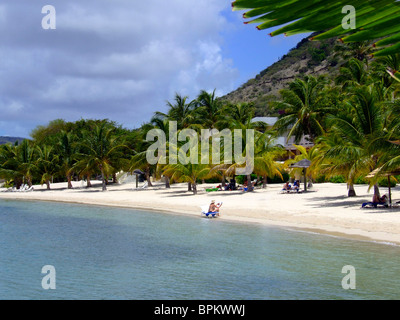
[322,85,389,196]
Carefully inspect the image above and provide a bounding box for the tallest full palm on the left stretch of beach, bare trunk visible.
[77,121,127,191]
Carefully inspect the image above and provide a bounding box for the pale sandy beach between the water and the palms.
[0,181,400,244]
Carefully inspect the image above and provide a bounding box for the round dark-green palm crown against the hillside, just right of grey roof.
[274,76,328,143]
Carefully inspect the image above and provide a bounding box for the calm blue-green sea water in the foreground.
[0,200,400,300]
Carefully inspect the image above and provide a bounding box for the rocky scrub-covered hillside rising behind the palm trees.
[221,32,341,117]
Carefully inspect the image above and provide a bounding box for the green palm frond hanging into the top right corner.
[232,0,400,56]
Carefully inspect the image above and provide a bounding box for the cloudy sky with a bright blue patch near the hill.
[0,0,306,137]
